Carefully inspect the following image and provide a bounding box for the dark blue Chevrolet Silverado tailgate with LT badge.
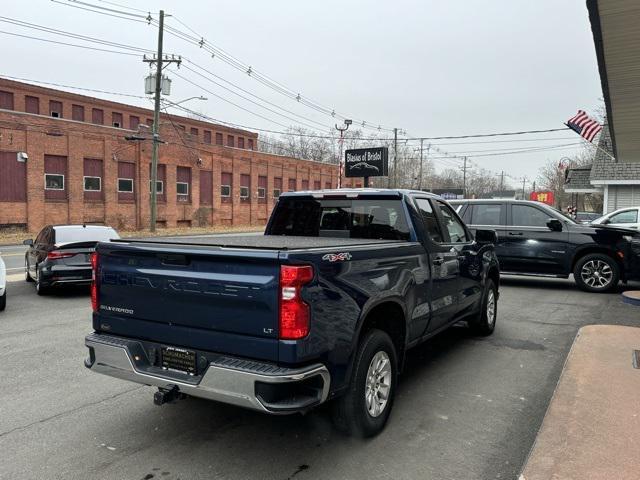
[94,243,280,360]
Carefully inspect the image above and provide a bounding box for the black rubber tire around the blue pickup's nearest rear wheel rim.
[332,330,398,438]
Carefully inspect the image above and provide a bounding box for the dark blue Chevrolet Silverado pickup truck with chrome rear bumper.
[85,189,500,437]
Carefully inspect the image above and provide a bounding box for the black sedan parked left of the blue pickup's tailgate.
[22,225,120,295]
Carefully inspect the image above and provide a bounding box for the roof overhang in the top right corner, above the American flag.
[587,0,640,162]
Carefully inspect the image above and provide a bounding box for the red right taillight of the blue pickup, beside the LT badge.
[279,265,313,340]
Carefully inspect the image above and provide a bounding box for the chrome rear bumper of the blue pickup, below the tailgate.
[85,333,331,414]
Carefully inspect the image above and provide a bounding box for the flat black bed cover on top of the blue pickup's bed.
[116,235,406,250]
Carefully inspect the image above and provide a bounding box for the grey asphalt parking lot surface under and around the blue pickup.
[0,252,640,480]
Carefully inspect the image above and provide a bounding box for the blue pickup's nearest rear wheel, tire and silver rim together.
[333,330,398,437]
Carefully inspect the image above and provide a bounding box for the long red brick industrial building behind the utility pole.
[0,79,350,231]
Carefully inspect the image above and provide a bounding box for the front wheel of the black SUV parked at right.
[573,253,620,293]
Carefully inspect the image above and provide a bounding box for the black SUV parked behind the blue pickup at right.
[451,200,640,292]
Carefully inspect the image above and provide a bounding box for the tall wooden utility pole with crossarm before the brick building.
[143,10,181,232]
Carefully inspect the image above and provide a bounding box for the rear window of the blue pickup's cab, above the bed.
[269,197,410,240]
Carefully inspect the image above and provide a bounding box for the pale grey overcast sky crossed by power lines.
[0,0,602,185]
